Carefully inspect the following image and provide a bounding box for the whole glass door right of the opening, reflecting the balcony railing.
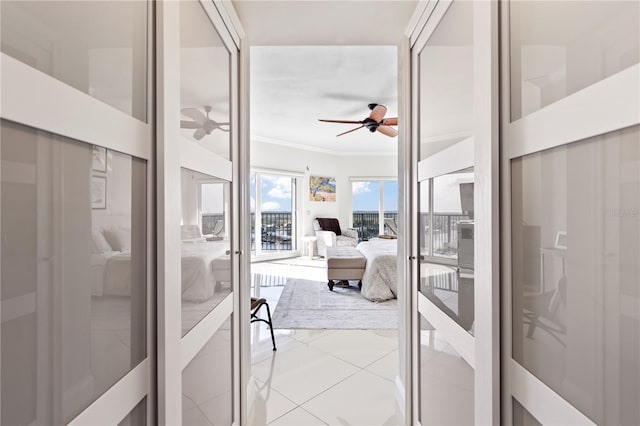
[408,0,500,425]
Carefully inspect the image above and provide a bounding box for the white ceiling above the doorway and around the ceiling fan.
[233,0,417,155]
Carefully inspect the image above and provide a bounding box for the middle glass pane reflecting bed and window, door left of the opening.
[180,168,232,335]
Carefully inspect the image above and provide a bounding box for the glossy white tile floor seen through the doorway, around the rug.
[249,261,401,426]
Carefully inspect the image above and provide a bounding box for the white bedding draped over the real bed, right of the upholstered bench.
[357,239,398,302]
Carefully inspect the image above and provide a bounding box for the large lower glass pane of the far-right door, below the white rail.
[511,126,640,424]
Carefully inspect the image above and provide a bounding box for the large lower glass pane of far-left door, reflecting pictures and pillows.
[0,120,147,424]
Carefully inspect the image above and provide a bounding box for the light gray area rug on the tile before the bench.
[272,278,398,330]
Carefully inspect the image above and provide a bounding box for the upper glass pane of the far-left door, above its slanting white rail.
[0,0,149,121]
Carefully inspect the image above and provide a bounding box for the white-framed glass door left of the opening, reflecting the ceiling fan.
[158,1,244,425]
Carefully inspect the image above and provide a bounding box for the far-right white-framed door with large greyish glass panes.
[501,1,640,424]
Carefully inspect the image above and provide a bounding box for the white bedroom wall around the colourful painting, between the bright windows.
[251,142,398,235]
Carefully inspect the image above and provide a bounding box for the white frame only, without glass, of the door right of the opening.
[407,0,500,424]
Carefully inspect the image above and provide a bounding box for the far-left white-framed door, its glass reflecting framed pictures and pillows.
[0,1,156,425]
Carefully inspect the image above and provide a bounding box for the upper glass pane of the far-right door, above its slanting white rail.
[509,1,640,121]
